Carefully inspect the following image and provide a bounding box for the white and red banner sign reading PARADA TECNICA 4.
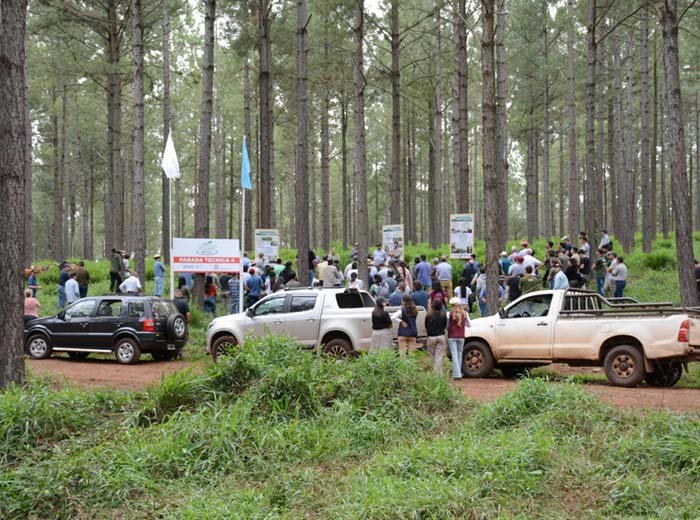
[171,238,241,273]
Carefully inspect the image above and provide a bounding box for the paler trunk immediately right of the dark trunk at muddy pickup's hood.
[495,0,506,249]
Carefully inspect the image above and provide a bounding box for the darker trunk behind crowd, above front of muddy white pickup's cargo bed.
[584,0,603,239]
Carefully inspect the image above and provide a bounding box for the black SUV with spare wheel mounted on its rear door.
[24,295,187,364]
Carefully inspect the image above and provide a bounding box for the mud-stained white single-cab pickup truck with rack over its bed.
[462,289,700,387]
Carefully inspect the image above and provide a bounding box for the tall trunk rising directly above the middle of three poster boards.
[389,0,401,224]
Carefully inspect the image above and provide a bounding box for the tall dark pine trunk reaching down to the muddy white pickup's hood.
[481,0,500,315]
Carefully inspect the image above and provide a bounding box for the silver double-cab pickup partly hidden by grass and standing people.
[207,287,425,360]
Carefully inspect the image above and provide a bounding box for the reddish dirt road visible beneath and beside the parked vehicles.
[27,356,700,412]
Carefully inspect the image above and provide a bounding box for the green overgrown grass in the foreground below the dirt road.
[0,348,700,519]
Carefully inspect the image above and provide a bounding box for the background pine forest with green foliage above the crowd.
[19,0,700,260]
